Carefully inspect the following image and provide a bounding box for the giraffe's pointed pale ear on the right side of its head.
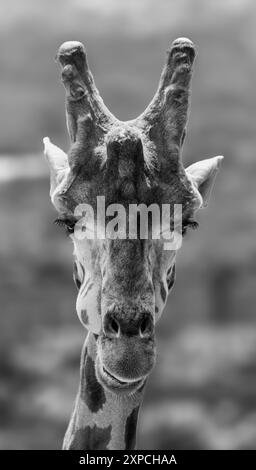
[186,156,224,207]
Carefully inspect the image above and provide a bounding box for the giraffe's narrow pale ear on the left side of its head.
[43,137,69,197]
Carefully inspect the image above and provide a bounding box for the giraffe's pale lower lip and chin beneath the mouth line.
[95,357,146,395]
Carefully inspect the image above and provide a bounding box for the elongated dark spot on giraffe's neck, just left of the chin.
[81,356,106,413]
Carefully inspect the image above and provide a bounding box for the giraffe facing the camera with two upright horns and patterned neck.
[44,38,223,450]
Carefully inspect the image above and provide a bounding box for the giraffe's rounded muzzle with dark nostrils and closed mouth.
[96,312,156,393]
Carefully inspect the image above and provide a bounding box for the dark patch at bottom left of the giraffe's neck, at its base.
[69,425,112,450]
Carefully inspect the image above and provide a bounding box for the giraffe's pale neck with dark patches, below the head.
[63,333,143,450]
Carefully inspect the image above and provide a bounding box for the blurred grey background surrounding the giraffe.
[0,0,256,449]
